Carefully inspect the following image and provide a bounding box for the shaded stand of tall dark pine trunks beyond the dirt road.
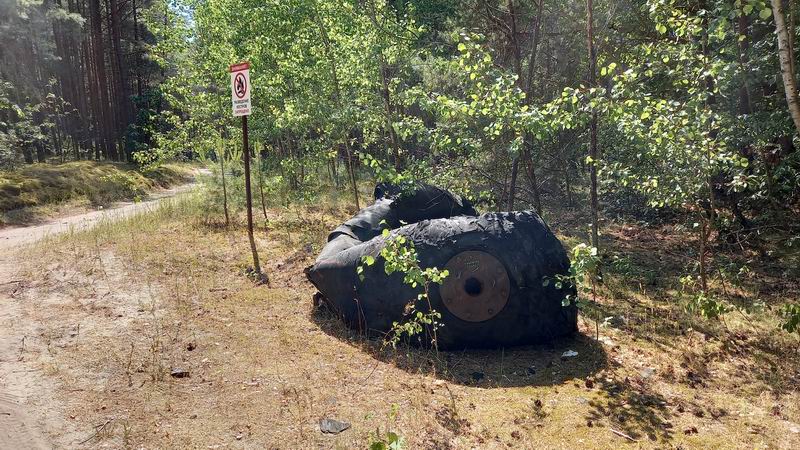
[0,0,166,166]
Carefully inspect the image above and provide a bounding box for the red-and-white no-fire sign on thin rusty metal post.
[231,62,263,279]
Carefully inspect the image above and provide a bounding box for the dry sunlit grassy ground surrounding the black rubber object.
[0,181,800,449]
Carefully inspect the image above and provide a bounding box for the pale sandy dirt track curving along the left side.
[0,178,203,450]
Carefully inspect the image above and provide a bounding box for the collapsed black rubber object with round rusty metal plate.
[307,186,577,349]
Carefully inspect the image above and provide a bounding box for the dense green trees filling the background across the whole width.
[0,0,800,213]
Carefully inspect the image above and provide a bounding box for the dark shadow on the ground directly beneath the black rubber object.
[312,307,607,388]
